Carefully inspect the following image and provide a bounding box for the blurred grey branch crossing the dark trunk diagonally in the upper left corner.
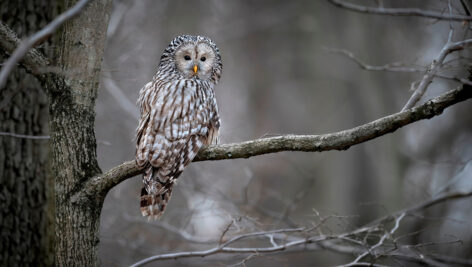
[0,0,90,90]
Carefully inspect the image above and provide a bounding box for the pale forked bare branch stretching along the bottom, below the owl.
[131,191,472,267]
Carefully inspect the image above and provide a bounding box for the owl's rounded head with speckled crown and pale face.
[160,35,223,83]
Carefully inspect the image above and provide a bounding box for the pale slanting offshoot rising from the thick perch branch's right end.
[402,38,472,111]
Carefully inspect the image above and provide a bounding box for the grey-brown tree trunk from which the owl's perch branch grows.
[48,0,111,266]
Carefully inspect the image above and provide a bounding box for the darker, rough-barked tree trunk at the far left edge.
[0,0,56,266]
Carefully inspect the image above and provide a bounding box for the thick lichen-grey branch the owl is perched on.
[75,86,472,201]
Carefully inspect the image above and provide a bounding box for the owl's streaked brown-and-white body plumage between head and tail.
[136,80,219,182]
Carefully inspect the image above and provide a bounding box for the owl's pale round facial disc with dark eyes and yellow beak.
[175,43,215,80]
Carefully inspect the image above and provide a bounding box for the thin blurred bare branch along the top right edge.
[328,0,472,21]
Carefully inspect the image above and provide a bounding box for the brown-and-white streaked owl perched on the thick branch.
[136,35,223,218]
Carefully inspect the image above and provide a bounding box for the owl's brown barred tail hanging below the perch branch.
[140,170,174,219]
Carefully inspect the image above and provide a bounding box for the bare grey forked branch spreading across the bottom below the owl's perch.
[131,192,472,267]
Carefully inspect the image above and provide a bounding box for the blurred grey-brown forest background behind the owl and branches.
[96,0,472,266]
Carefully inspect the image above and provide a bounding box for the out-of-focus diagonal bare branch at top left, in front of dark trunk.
[0,0,90,90]
